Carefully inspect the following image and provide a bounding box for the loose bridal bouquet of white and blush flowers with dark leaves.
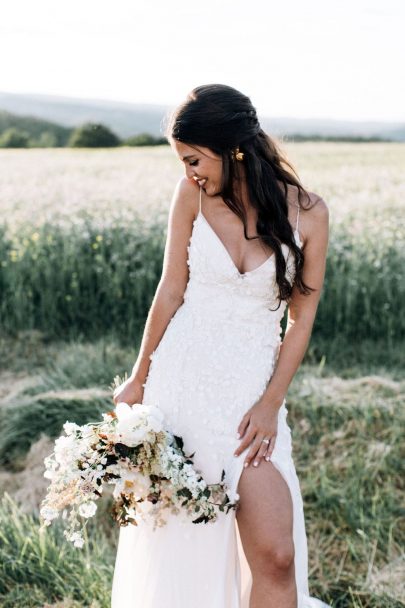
[40,396,239,548]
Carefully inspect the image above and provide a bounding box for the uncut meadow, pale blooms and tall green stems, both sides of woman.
[0,143,405,367]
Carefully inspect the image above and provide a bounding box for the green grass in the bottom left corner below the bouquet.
[0,494,114,608]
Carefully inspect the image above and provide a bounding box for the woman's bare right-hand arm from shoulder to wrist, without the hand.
[261,197,329,409]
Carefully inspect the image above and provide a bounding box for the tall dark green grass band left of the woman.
[0,215,163,341]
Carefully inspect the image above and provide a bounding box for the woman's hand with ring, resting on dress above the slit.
[235,401,278,467]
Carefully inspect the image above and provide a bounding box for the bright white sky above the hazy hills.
[0,0,405,121]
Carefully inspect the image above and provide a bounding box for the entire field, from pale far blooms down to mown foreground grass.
[0,142,405,608]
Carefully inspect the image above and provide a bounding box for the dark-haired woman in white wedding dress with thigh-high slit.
[112,84,328,608]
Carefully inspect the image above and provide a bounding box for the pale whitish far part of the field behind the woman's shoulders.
[0,142,405,230]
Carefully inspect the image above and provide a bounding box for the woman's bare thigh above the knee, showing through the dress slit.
[236,461,294,572]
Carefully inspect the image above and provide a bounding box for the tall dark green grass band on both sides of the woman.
[0,212,405,350]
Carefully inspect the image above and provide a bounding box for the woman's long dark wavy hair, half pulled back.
[165,84,314,307]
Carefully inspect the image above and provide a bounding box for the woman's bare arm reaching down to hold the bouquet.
[114,177,198,403]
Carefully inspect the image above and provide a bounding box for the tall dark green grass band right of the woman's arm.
[314,210,405,349]
